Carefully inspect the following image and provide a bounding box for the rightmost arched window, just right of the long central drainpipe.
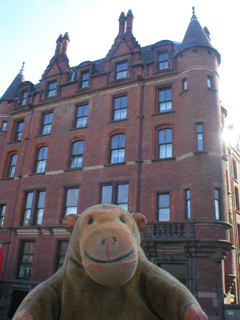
[158,129,172,159]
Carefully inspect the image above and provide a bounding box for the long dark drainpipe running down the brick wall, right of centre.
[136,76,144,212]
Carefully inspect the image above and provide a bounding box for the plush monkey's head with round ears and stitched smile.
[63,205,146,287]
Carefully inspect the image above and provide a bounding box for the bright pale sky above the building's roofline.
[0,0,240,140]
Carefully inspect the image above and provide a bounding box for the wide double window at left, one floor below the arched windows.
[22,191,46,226]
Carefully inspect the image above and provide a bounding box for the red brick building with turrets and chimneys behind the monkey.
[0,10,240,320]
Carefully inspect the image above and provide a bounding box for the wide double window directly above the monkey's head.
[100,183,128,210]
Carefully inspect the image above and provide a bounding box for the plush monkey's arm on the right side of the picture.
[144,264,208,320]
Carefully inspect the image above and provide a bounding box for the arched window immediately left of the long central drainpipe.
[110,134,125,163]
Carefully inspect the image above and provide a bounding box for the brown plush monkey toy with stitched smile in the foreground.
[13,205,208,320]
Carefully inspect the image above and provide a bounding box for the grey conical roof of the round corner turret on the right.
[178,7,220,62]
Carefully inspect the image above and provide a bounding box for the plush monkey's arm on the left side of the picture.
[13,283,60,320]
